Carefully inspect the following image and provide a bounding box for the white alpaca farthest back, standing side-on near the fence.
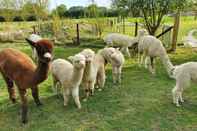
[103,29,147,57]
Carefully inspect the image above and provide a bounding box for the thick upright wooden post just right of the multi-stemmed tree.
[171,10,180,51]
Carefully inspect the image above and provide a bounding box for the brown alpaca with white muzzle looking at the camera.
[0,39,53,123]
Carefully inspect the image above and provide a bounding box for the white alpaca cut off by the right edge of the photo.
[172,62,197,106]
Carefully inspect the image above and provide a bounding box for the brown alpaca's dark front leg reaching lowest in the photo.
[19,89,28,124]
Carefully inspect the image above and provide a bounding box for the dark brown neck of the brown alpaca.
[33,60,49,84]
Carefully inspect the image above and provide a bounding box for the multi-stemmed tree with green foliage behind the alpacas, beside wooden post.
[112,0,186,35]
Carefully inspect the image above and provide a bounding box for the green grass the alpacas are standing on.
[0,40,197,131]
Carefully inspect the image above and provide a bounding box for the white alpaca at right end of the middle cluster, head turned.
[103,47,125,83]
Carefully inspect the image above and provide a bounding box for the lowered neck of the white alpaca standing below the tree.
[160,54,174,77]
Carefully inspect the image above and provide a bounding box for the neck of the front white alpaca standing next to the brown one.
[72,67,84,85]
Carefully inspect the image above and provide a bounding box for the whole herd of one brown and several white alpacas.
[0,29,197,123]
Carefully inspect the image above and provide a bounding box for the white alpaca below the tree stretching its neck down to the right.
[138,35,174,77]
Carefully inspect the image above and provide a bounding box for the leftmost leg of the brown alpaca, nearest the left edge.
[3,75,16,103]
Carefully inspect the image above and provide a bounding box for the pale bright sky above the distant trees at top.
[49,0,111,10]
